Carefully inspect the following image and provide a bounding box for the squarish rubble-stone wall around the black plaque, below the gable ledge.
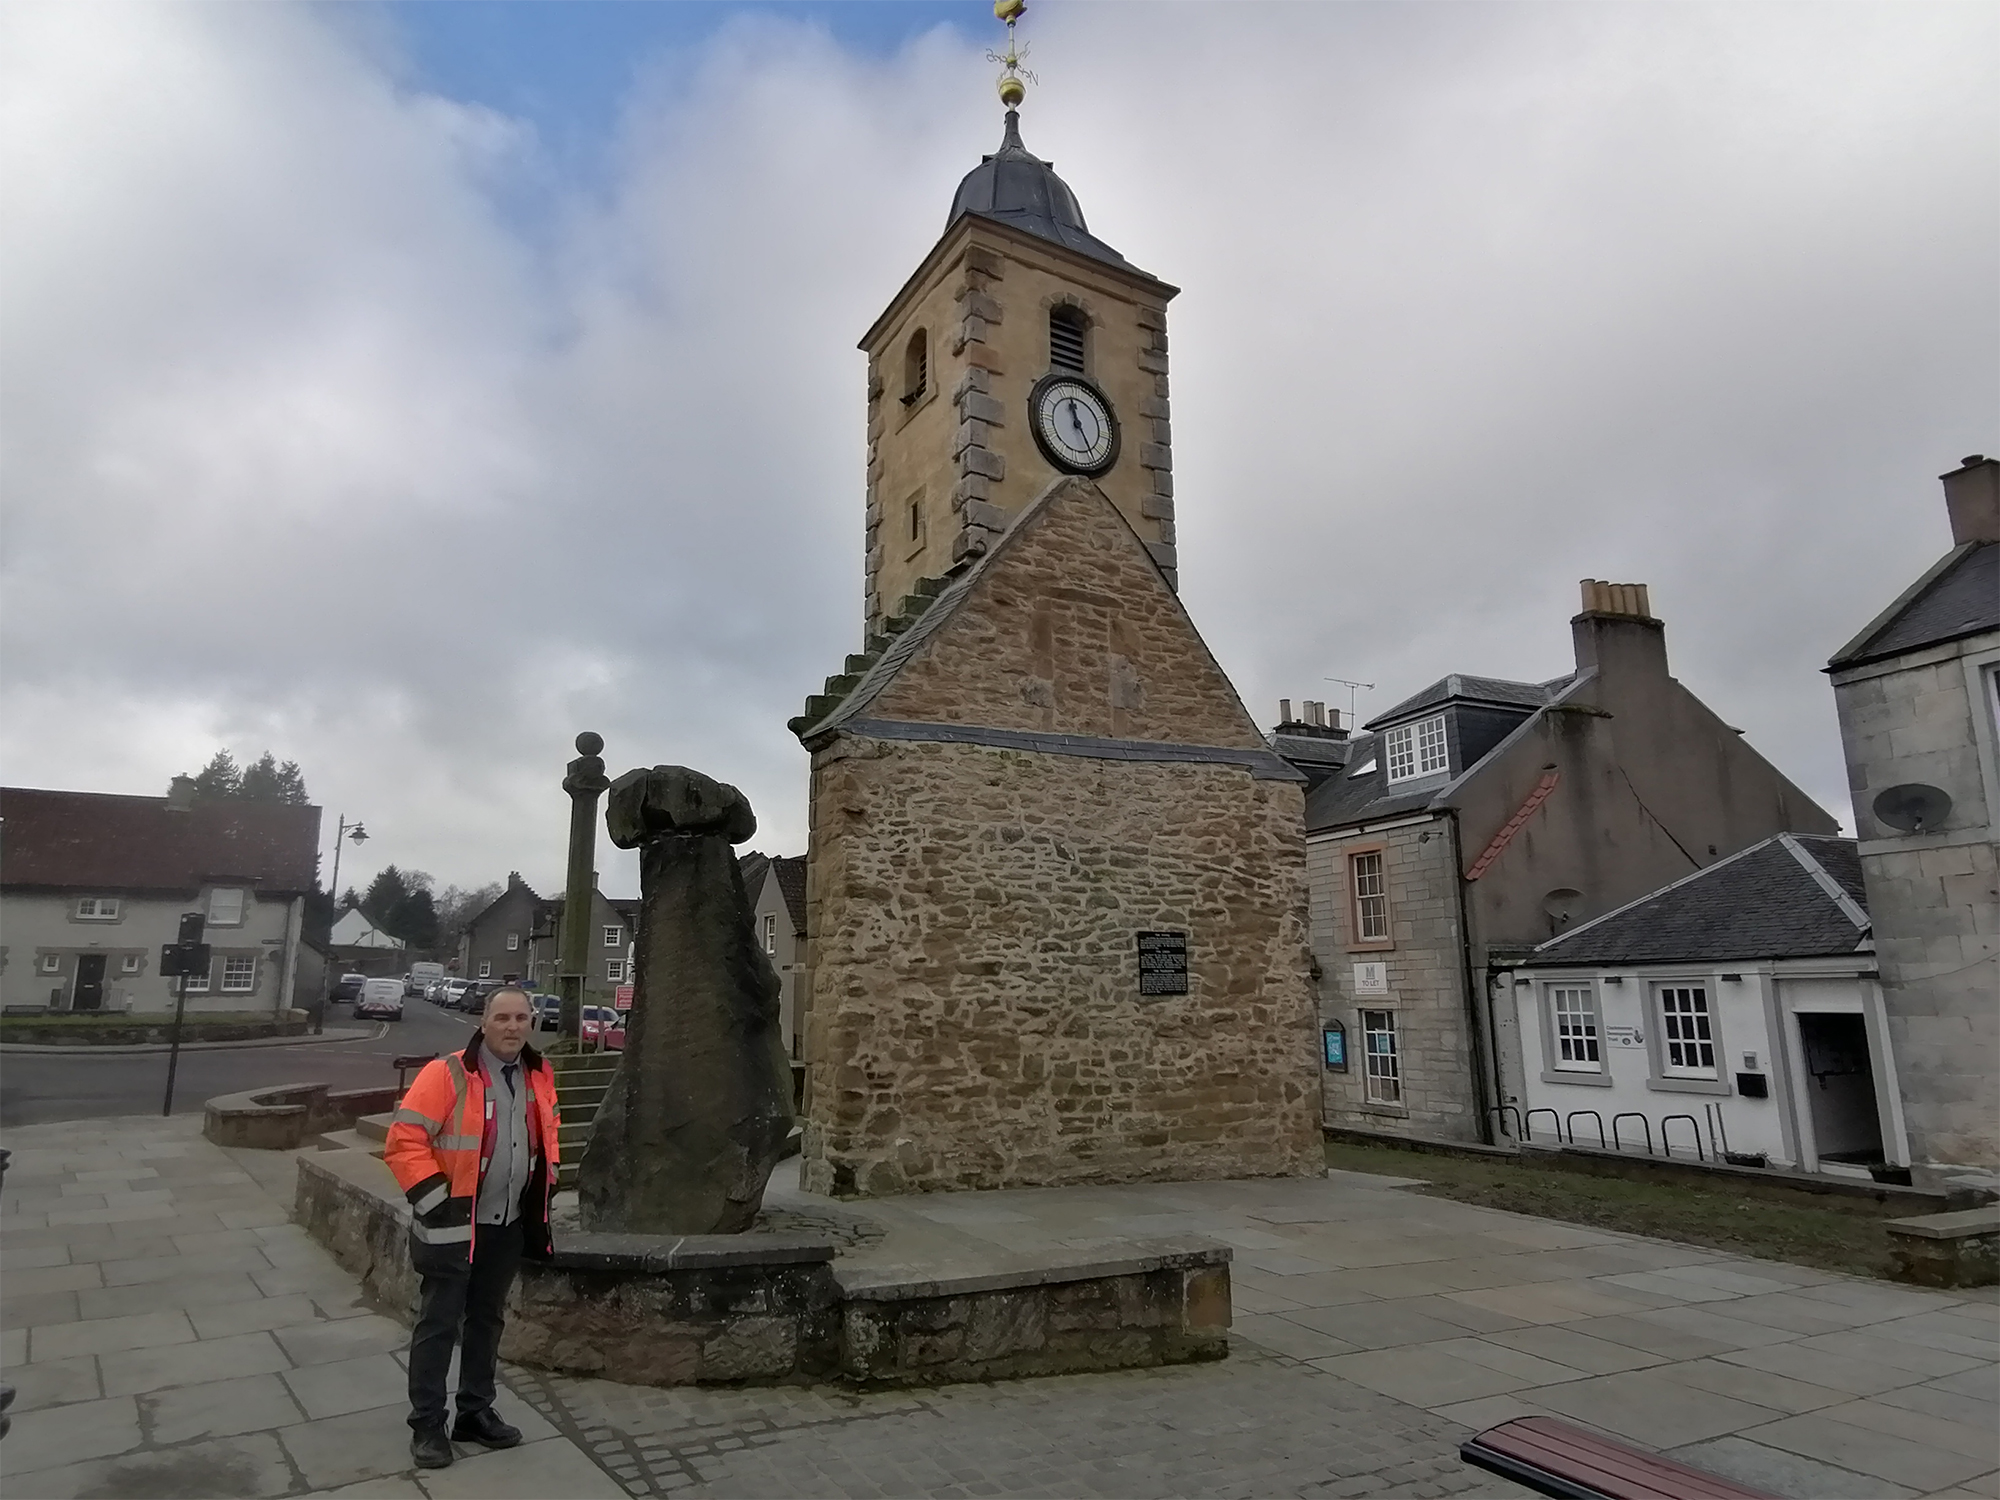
[804,740,1324,1194]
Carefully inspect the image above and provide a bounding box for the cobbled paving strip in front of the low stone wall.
[508,1342,1528,1500]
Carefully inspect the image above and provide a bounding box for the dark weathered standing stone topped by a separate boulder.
[576,766,792,1234]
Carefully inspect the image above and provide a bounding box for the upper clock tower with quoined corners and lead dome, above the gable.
[860,104,1178,636]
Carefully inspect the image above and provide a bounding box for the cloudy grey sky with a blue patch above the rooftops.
[0,0,2000,894]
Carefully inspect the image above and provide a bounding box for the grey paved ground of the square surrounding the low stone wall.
[0,1116,2000,1500]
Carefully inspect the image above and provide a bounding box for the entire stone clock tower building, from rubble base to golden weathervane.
[790,23,1324,1196]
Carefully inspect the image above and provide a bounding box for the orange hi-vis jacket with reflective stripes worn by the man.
[382,1036,558,1270]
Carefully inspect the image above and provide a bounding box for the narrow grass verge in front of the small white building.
[1326,1140,1888,1276]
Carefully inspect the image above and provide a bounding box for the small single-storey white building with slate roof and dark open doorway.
[1494,834,1910,1176]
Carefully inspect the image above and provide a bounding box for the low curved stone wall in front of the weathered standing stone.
[296,1152,1230,1386]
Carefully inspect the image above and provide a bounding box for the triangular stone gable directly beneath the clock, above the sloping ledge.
[868,480,1264,750]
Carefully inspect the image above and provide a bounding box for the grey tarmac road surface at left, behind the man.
[0,1000,478,1126]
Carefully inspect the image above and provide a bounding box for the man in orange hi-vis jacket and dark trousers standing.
[382,986,558,1468]
